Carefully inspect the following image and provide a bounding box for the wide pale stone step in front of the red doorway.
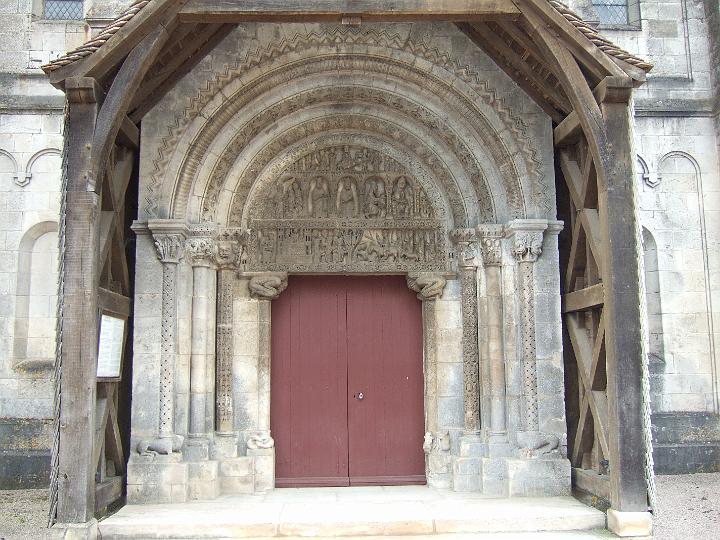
[99,486,612,540]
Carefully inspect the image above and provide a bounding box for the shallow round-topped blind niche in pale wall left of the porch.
[14,221,58,369]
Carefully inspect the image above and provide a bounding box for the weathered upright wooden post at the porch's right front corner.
[596,77,648,512]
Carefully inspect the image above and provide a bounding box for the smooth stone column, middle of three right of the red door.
[478,225,508,448]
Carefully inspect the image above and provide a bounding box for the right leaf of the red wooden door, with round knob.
[347,276,425,485]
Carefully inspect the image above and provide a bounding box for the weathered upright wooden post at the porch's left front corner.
[57,78,103,523]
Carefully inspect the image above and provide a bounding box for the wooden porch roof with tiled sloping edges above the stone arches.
[43,0,652,123]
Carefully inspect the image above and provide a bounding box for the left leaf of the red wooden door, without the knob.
[270,276,348,487]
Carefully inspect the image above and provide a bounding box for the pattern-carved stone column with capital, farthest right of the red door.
[508,220,548,438]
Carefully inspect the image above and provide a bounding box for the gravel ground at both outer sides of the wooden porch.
[0,473,720,540]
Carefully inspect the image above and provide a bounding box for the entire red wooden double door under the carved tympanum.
[271,276,425,487]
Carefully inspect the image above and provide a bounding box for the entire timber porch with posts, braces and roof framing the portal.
[44,0,651,523]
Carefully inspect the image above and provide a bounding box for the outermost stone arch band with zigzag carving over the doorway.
[149,26,554,225]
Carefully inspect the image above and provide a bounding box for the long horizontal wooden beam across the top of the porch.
[179,0,520,23]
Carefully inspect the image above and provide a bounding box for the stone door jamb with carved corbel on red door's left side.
[247,274,288,491]
